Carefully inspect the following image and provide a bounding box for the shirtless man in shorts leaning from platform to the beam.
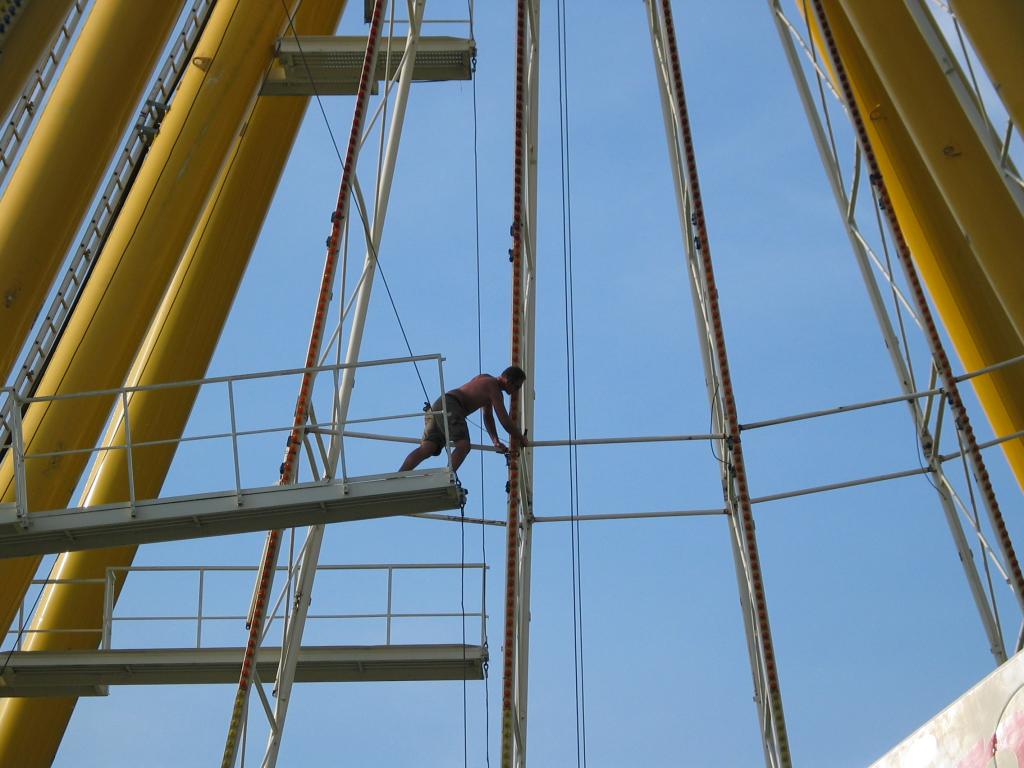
[398,366,529,472]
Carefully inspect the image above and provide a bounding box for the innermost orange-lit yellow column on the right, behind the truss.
[798,0,1024,487]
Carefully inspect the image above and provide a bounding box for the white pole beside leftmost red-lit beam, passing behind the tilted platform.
[262,6,426,768]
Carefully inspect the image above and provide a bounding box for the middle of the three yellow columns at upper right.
[841,0,1024,339]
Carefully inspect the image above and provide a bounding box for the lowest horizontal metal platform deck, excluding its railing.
[0,645,487,698]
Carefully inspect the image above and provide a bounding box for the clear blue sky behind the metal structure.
[24,0,1021,766]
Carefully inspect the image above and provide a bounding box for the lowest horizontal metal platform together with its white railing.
[0,563,487,698]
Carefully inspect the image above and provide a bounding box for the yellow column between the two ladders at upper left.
[0,0,183,378]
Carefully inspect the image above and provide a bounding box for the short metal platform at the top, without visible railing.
[260,35,476,96]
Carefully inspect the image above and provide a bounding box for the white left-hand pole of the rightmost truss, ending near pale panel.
[768,0,1007,666]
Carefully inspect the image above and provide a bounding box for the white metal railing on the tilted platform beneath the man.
[0,354,451,526]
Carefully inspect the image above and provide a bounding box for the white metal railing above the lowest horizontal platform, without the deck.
[4,563,487,650]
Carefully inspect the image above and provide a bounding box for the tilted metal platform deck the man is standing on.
[0,468,464,557]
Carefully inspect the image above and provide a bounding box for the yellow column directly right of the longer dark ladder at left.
[0,0,299,651]
